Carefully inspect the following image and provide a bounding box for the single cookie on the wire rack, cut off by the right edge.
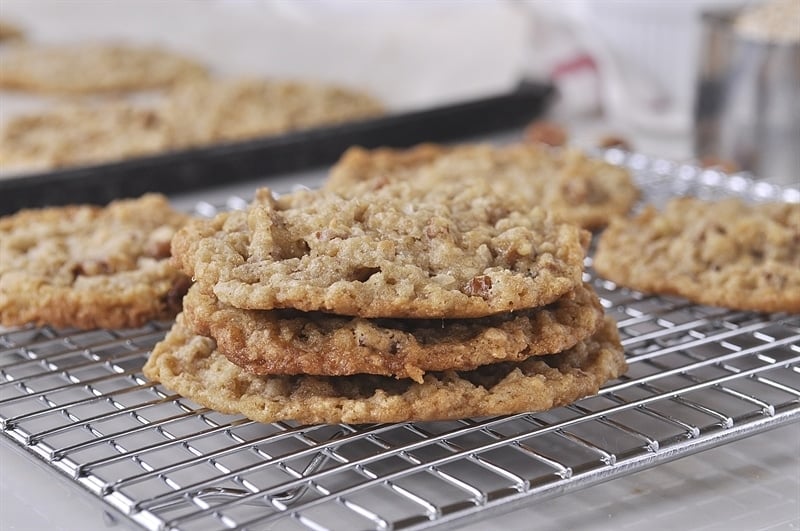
[594,197,800,312]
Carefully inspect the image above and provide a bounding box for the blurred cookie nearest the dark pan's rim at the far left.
[0,102,171,174]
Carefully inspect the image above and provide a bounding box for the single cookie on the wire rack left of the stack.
[0,194,189,329]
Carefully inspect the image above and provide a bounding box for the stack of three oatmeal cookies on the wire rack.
[145,182,625,423]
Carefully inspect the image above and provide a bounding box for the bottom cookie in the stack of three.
[144,315,626,423]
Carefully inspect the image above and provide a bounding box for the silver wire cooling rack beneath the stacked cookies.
[0,150,800,530]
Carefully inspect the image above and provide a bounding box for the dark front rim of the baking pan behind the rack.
[0,81,554,214]
